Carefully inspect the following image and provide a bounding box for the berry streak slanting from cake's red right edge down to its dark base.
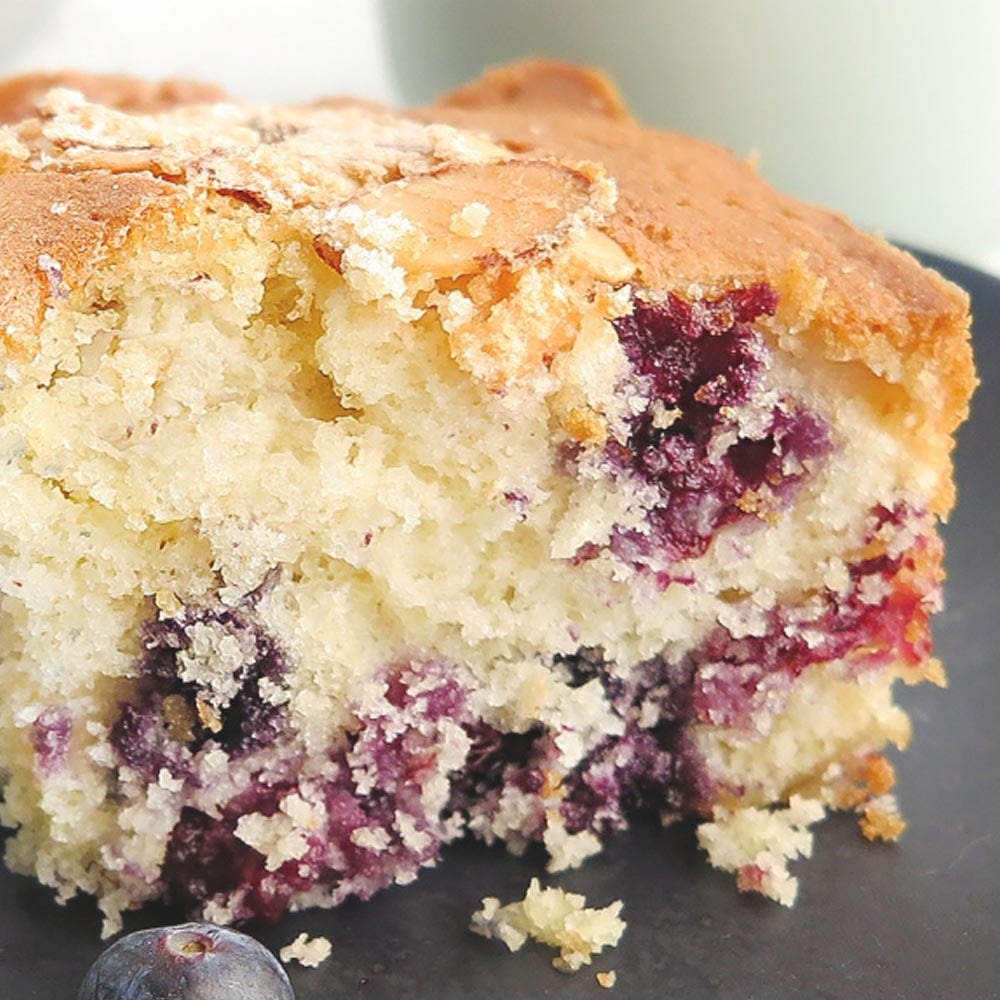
[562,505,940,832]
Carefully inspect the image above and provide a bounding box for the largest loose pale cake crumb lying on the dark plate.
[470,878,625,972]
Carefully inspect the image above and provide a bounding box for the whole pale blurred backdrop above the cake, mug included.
[0,0,1000,275]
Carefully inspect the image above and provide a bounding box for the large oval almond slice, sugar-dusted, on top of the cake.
[317,160,615,280]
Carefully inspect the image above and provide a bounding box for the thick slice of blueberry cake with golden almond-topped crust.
[0,63,975,929]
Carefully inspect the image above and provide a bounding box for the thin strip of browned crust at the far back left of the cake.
[0,70,225,124]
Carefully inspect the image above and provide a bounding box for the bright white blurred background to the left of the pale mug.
[0,0,394,101]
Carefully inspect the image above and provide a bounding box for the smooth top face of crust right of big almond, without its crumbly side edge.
[432,61,968,346]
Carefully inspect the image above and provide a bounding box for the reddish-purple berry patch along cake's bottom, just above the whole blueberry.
[162,663,469,921]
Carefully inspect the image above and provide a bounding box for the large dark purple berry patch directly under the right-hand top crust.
[578,283,830,585]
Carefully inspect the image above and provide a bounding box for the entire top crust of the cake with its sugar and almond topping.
[0,60,975,482]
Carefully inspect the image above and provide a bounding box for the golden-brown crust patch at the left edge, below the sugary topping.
[0,171,178,360]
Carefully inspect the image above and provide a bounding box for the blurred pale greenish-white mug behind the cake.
[381,0,1000,272]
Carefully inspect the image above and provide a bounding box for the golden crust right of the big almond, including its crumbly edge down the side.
[430,61,976,512]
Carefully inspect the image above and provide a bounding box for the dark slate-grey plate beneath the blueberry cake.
[0,257,1000,1000]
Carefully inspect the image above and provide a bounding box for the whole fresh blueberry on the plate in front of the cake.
[77,924,295,1000]
